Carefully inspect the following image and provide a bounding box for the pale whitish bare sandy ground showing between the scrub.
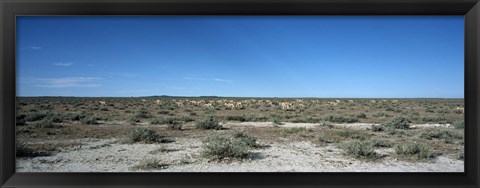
[17,122,464,172]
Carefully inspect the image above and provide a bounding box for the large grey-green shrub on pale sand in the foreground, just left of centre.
[202,135,250,159]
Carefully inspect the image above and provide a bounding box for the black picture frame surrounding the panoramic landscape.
[0,0,480,187]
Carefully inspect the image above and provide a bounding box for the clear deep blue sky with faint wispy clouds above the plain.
[16,16,464,98]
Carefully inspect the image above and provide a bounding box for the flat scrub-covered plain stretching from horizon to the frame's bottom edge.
[16,96,464,172]
